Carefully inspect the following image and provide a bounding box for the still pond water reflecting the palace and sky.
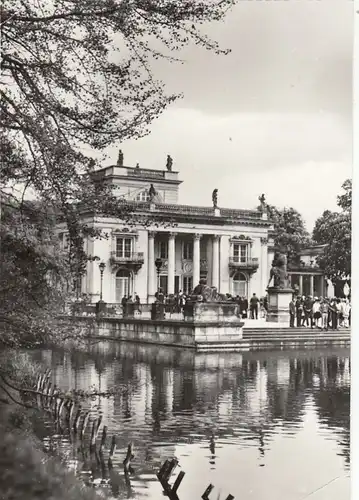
[28,343,350,500]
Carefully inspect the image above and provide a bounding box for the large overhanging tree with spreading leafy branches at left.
[0,0,235,344]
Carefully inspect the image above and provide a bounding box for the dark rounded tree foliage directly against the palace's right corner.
[266,205,310,264]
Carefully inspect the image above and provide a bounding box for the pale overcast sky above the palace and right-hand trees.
[107,0,353,230]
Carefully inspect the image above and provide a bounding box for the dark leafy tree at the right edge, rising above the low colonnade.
[313,179,352,283]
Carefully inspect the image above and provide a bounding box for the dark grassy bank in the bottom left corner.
[0,350,103,500]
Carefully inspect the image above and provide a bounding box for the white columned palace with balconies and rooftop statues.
[60,156,334,303]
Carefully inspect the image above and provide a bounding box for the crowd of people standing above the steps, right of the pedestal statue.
[289,296,351,330]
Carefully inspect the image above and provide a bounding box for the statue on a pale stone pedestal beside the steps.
[267,252,294,326]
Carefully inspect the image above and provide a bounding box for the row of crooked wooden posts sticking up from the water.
[35,369,234,500]
